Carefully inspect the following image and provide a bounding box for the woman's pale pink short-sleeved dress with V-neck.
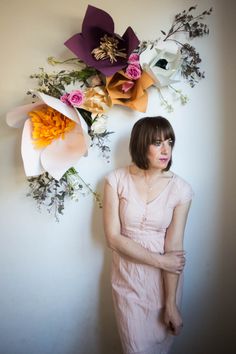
[106,167,193,354]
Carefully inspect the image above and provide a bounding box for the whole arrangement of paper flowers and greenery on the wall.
[7,5,212,221]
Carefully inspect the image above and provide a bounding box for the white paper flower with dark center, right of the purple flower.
[140,46,182,88]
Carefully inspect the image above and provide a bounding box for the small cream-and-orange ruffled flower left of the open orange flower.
[80,86,112,118]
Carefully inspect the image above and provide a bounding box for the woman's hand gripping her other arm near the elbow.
[160,251,185,274]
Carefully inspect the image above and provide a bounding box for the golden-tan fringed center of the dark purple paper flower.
[91,34,127,64]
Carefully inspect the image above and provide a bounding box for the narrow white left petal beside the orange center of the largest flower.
[21,119,45,176]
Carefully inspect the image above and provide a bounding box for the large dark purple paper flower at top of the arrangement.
[65,5,139,76]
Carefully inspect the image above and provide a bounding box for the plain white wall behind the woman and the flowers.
[0,0,236,354]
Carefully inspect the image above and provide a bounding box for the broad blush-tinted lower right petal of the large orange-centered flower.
[41,125,88,180]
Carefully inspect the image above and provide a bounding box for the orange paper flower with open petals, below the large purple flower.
[106,70,154,112]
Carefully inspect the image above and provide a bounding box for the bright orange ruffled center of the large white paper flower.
[28,106,76,149]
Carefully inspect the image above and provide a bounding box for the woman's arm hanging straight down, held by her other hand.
[164,201,191,335]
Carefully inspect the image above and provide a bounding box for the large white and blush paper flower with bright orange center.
[7,93,89,180]
